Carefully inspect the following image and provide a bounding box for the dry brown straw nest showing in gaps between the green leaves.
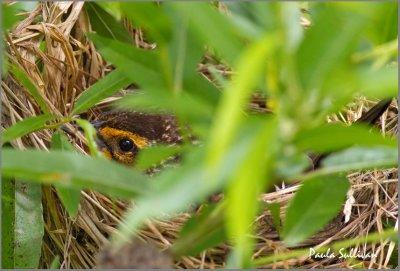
[1,2,398,269]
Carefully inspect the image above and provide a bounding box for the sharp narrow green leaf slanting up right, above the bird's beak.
[72,69,132,114]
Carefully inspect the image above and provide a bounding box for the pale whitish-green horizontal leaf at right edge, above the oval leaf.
[321,146,398,172]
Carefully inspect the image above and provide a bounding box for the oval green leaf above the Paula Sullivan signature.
[283,175,350,246]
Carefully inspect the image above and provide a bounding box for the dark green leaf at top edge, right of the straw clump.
[85,2,133,43]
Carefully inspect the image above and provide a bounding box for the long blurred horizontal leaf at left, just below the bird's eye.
[1,148,148,198]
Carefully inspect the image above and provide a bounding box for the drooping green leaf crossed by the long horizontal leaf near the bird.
[51,132,81,217]
